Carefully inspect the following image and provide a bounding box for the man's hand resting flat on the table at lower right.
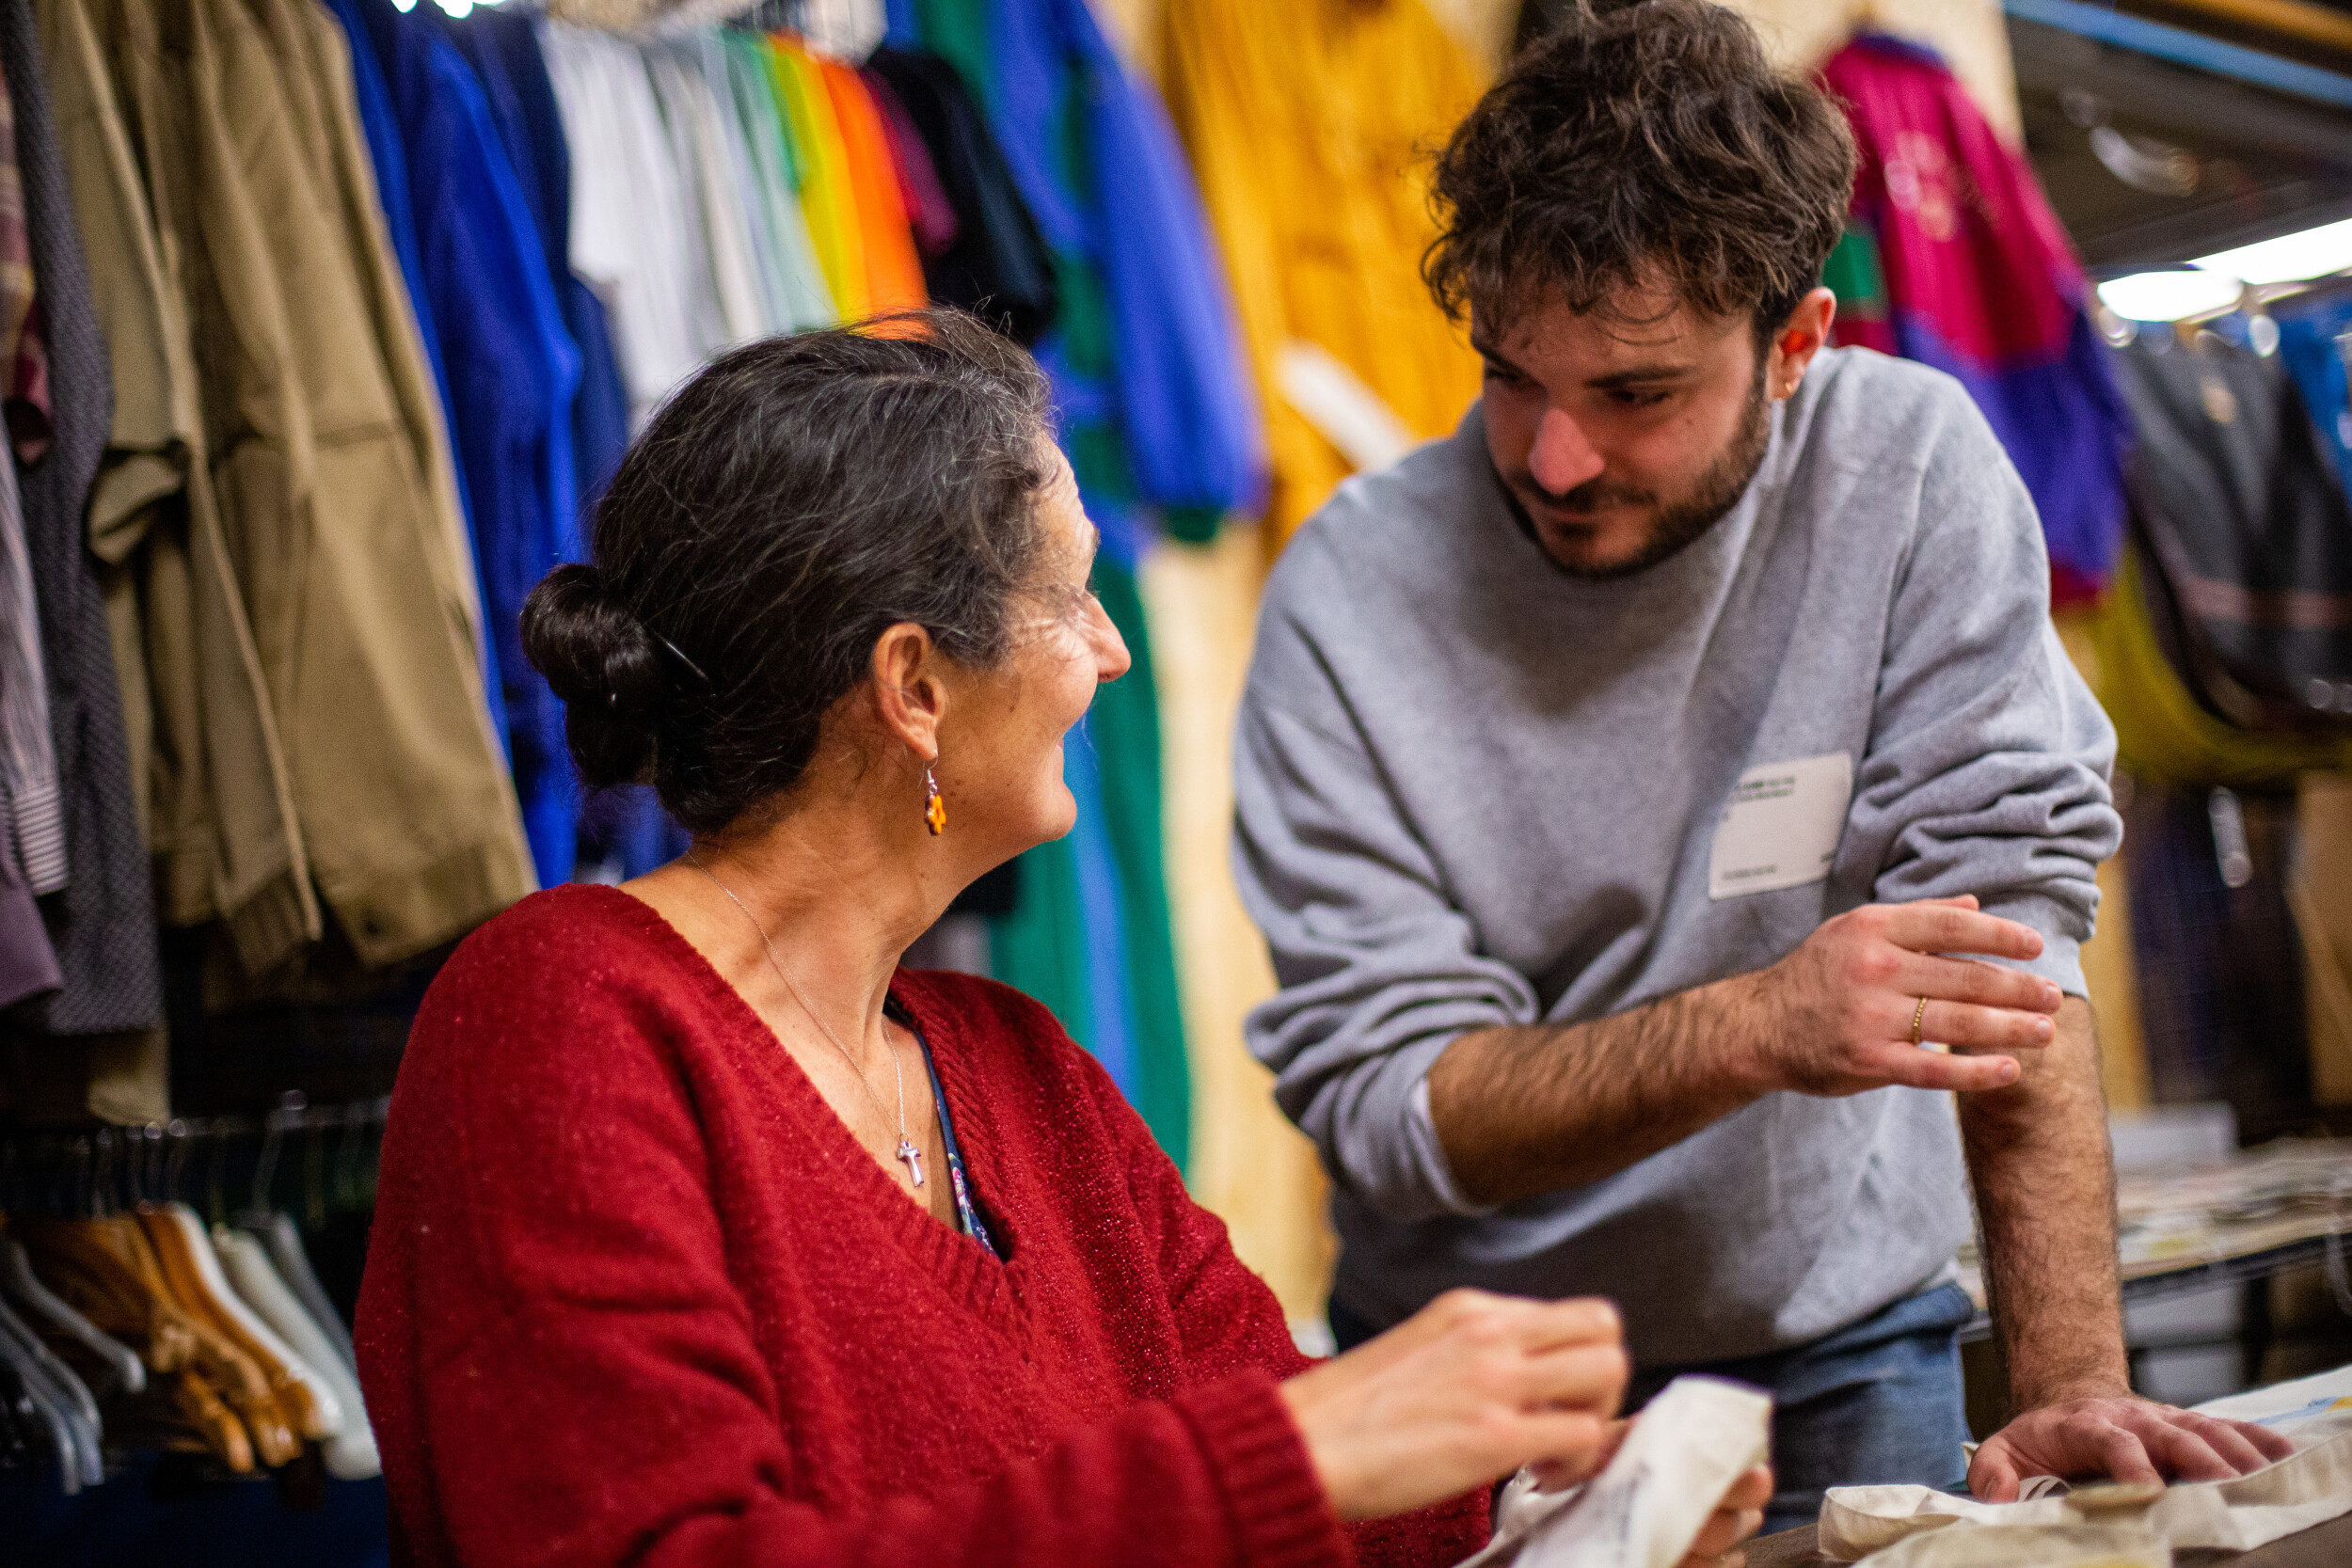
[1969,1394,2296,1502]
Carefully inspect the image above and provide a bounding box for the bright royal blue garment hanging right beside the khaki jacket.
[351,0,581,886]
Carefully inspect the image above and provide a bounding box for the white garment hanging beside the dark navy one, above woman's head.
[539,21,708,428]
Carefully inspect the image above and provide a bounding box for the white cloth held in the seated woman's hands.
[1461,1378,1772,1568]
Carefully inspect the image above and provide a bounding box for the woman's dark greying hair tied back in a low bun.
[522,310,1054,834]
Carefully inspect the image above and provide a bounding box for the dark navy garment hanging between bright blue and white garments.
[445,7,635,515]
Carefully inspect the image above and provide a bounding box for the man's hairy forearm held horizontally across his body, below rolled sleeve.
[1430,980,1762,1204]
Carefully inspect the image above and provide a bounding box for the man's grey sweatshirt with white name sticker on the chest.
[1235,350,2122,1366]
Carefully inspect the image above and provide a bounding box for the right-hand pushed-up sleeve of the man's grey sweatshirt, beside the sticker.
[1839,386,2124,997]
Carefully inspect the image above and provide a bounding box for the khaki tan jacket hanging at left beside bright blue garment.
[40,0,532,978]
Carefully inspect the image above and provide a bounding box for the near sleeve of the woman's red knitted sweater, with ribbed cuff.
[360,955,1348,1568]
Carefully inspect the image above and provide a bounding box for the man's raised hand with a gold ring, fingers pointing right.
[1748,898,2060,1096]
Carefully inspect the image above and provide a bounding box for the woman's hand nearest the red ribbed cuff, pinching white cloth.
[1282,1291,1628,1519]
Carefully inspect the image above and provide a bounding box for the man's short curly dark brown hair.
[1423,0,1853,334]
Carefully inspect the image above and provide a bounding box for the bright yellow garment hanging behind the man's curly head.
[1165,0,1482,550]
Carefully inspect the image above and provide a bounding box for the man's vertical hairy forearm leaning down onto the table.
[1960,997,2129,1411]
